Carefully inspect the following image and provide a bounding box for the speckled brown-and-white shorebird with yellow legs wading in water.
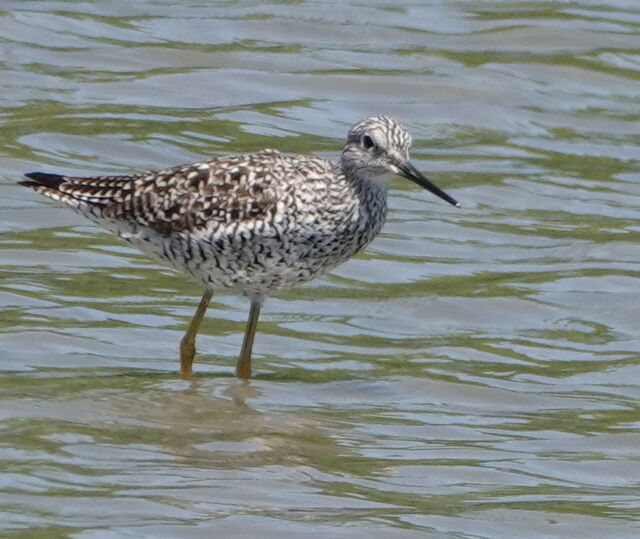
[19,115,459,380]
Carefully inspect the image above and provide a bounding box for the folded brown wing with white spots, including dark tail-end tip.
[22,151,292,233]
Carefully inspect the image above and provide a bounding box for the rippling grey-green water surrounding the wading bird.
[0,0,640,539]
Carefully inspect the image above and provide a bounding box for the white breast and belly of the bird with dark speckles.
[117,181,386,296]
